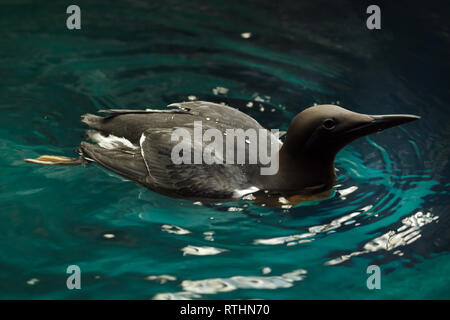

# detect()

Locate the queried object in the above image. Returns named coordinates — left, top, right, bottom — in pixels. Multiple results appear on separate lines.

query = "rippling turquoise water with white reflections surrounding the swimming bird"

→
left=0, top=0, right=450, bottom=299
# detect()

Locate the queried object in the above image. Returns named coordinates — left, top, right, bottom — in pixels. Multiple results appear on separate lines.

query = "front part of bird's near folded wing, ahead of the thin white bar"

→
left=140, top=128, right=254, bottom=199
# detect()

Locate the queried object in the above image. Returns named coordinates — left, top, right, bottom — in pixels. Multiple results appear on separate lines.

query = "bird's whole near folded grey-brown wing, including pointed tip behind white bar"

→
left=80, top=128, right=257, bottom=199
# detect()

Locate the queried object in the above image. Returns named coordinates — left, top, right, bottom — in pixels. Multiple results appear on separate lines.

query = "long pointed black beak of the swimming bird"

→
left=347, top=114, right=420, bottom=137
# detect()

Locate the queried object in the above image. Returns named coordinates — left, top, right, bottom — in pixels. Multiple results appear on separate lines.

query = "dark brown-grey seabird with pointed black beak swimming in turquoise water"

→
left=25, top=101, right=420, bottom=204
